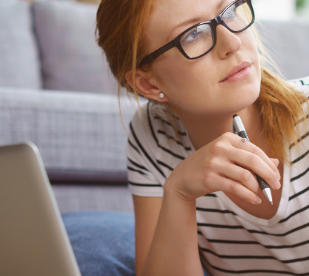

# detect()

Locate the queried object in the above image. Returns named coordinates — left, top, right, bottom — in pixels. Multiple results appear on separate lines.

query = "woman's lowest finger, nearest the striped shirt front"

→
left=215, top=175, right=262, bottom=205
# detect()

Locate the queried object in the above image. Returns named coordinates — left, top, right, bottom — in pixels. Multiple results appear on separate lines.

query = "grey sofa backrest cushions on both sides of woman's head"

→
left=0, top=0, right=309, bottom=94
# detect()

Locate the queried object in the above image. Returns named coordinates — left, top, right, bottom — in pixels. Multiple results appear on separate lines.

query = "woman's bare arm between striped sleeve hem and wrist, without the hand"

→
left=134, top=191, right=203, bottom=276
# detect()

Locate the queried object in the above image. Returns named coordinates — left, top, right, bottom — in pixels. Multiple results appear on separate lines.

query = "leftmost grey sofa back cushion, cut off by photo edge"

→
left=0, top=0, right=41, bottom=89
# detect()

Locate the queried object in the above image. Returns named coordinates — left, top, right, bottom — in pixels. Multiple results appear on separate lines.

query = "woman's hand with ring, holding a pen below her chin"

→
left=165, top=132, right=280, bottom=204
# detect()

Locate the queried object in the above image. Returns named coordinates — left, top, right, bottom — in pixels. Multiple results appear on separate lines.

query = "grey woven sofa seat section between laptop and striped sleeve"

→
left=0, top=87, right=135, bottom=184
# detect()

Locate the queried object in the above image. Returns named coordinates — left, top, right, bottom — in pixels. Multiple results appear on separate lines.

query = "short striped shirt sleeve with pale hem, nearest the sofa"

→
left=126, top=106, right=164, bottom=197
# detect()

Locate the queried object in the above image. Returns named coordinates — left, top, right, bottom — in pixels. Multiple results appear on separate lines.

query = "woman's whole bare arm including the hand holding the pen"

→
left=134, top=134, right=277, bottom=276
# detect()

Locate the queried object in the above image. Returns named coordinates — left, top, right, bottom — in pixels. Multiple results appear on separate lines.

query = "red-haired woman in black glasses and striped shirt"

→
left=97, top=0, right=309, bottom=276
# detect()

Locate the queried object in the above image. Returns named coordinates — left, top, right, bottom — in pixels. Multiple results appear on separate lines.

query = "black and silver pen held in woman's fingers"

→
left=233, top=114, right=273, bottom=204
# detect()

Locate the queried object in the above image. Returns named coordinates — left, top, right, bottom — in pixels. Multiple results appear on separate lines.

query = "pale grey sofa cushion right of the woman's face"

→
left=257, top=19, right=309, bottom=79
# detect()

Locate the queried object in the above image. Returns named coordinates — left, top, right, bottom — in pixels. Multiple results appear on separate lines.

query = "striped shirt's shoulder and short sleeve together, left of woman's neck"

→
left=126, top=102, right=188, bottom=196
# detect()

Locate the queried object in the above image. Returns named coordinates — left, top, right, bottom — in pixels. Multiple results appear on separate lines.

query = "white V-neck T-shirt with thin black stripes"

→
left=126, top=77, right=309, bottom=276
